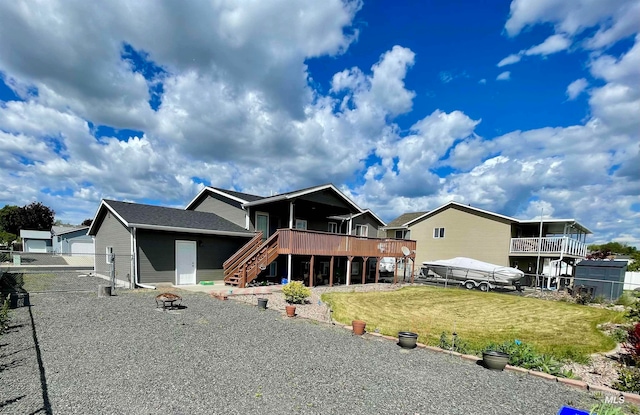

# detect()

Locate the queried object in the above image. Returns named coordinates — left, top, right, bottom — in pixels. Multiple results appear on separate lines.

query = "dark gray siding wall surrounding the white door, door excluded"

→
left=137, top=229, right=249, bottom=284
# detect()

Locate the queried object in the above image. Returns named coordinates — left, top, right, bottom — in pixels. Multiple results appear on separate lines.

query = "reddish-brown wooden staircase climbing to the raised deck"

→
left=222, top=231, right=279, bottom=288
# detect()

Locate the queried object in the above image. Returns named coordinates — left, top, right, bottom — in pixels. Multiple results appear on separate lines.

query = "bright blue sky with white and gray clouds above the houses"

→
left=0, top=0, right=640, bottom=246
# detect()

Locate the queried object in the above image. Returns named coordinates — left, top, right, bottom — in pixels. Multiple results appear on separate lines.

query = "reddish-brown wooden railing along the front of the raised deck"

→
left=278, top=229, right=416, bottom=257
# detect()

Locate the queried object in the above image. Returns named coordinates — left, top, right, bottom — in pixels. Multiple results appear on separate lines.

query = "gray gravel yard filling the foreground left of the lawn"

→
left=0, top=282, right=596, bottom=415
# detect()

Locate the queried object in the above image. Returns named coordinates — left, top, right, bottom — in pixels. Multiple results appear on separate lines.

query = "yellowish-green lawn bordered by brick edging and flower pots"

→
left=322, top=287, right=624, bottom=358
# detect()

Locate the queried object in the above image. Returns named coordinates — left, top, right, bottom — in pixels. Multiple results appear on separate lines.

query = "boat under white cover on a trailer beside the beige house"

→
left=422, top=257, right=524, bottom=291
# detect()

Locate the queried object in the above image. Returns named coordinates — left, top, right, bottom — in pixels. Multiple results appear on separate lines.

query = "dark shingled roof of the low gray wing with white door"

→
left=104, top=200, right=251, bottom=235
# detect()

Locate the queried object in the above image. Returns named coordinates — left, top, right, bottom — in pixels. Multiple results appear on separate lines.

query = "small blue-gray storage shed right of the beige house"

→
left=573, top=260, right=627, bottom=301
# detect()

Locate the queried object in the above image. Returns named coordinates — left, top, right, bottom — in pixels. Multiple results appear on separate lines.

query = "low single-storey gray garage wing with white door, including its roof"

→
left=88, top=200, right=253, bottom=287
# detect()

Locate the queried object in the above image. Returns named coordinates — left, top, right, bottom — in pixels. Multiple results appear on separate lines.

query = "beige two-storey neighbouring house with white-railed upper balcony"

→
left=384, top=202, right=592, bottom=282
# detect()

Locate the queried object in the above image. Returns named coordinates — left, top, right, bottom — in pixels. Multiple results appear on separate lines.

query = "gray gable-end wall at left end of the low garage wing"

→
left=95, top=211, right=131, bottom=281
